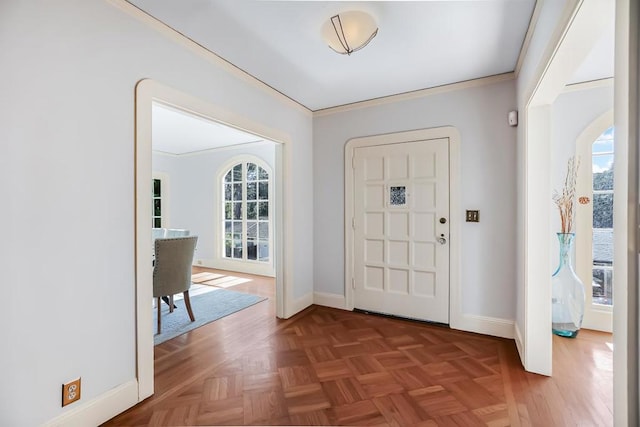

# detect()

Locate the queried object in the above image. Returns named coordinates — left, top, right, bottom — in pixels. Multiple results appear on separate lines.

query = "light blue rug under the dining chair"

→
left=153, top=285, right=266, bottom=345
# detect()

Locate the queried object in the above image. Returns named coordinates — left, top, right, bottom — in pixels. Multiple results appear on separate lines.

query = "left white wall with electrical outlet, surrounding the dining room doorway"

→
left=0, top=0, right=313, bottom=426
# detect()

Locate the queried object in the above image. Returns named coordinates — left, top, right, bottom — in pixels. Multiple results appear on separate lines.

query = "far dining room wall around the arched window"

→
left=152, top=142, right=275, bottom=270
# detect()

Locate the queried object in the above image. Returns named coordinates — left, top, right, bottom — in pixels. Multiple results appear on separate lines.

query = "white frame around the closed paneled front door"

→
left=344, top=126, right=462, bottom=329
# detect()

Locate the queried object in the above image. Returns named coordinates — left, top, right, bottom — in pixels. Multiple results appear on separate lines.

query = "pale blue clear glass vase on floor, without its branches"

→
left=551, top=233, right=585, bottom=338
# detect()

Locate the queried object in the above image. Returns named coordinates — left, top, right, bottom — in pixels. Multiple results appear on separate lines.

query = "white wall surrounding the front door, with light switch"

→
left=313, top=80, right=516, bottom=320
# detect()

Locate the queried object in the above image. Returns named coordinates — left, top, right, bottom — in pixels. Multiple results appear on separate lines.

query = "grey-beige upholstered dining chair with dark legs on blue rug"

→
left=153, top=236, right=198, bottom=333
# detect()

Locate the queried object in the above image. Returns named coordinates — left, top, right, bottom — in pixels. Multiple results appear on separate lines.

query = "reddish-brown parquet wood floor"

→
left=105, top=269, right=613, bottom=427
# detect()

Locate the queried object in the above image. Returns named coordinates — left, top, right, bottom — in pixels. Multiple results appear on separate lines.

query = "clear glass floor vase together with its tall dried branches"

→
left=551, top=157, right=585, bottom=338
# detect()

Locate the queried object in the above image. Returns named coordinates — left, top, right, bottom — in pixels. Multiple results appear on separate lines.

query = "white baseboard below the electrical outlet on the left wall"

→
left=44, top=380, right=138, bottom=427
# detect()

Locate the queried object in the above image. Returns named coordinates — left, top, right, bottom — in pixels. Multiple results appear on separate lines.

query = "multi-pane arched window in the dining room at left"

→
left=222, top=161, right=271, bottom=262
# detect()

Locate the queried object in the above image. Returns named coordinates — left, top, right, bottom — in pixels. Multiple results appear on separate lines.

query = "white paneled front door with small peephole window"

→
left=353, top=138, right=449, bottom=323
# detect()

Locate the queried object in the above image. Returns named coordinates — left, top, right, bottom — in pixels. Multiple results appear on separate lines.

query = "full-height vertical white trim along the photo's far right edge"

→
left=613, top=0, right=640, bottom=426
